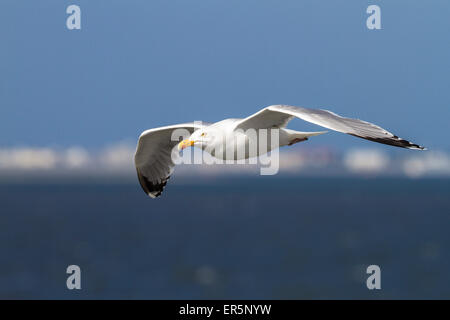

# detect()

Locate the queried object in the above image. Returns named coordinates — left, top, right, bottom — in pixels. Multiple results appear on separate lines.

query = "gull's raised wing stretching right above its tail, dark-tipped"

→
left=236, top=105, right=425, bottom=150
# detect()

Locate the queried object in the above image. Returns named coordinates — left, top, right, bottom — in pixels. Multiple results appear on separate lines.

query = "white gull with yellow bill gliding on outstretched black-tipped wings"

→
left=134, top=105, right=425, bottom=198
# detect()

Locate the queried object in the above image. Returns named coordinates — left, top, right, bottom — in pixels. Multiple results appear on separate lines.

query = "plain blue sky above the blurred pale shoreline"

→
left=0, top=0, right=450, bottom=150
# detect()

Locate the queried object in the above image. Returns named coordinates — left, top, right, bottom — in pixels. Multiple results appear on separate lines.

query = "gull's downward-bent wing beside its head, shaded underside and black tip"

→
left=134, top=123, right=205, bottom=198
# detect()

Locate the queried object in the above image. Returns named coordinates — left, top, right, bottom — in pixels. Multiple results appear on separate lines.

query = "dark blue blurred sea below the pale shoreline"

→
left=0, top=176, right=450, bottom=299
